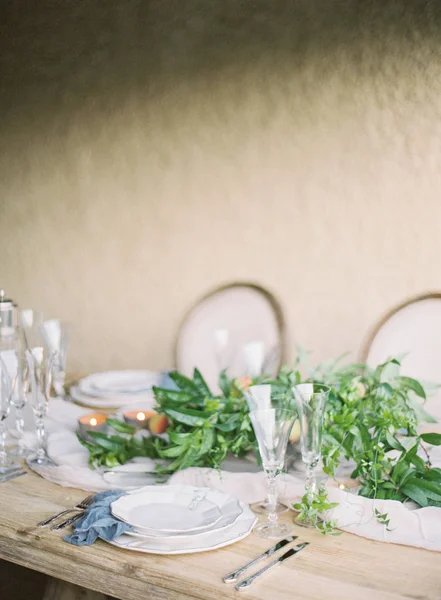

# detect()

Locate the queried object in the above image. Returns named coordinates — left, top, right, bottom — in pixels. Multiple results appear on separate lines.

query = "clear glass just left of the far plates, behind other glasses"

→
left=42, top=319, right=70, bottom=398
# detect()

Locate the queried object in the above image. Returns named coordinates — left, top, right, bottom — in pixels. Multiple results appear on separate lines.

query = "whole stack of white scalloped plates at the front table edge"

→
left=110, top=485, right=256, bottom=554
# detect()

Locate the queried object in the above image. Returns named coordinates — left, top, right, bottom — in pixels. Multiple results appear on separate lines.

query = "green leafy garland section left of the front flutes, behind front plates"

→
left=79, top=369, right=255, bottom=473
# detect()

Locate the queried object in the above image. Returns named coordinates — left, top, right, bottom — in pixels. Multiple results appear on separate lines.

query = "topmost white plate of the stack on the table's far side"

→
left=78, top=370, right=162, bottom=396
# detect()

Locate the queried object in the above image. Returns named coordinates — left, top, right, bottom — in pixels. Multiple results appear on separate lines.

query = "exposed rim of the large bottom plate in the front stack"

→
left=109, top=502, right=257, bottom=554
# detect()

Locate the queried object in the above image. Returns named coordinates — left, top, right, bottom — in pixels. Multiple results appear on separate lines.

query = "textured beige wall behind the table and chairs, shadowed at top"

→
left=0, top=0, right=441, bottom=370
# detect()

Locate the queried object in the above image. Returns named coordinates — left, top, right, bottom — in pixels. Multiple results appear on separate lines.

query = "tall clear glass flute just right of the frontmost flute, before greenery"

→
left=292, top=383, right=330, bottom=527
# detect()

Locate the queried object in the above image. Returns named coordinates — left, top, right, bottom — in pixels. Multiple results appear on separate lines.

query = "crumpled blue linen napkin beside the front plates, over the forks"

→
left=64, top=490, right=133, bottom=546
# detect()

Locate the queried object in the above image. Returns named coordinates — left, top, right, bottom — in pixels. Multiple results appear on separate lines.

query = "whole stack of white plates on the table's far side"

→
left=70, top=371, right=163, bottom=408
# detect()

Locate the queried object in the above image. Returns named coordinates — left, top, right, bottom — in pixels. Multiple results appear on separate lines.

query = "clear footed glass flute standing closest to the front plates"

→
left=250, top=404, right=296, bottom=539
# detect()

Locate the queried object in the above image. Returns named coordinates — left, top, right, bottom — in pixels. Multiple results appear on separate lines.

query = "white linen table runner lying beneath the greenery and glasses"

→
left=18, top=399, right=441, bottom=552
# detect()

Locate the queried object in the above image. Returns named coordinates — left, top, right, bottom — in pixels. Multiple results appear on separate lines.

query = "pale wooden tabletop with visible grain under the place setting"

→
left=0, top=473, right=441, bottom=600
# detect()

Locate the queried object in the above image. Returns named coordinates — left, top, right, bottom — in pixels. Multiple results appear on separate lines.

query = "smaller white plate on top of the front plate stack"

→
left=111, top=485, right=222, bottom=534
